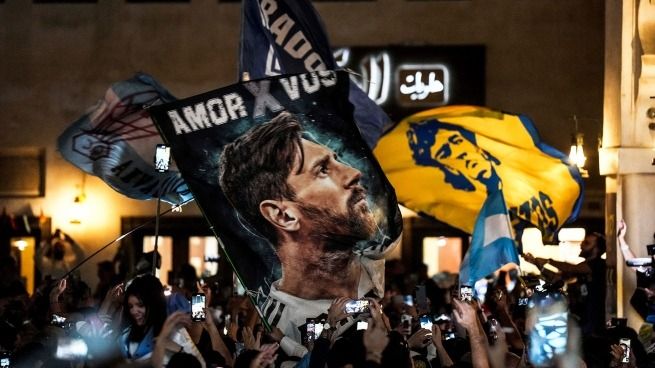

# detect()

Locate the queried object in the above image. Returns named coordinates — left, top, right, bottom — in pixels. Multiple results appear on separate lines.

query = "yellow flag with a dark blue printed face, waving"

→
left=374, top=106, right=583, bottom=239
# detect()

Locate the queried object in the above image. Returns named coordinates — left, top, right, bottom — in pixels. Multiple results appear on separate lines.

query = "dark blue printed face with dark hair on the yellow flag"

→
left=407, top=120, right=500, bottom=191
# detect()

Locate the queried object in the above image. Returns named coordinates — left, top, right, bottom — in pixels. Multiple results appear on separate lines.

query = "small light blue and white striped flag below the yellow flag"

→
left=459, top=189, right=519, bottom=286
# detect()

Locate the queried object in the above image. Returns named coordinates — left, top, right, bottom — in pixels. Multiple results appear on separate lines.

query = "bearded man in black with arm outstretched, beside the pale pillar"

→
left=523, top=232, right=607, bottom=334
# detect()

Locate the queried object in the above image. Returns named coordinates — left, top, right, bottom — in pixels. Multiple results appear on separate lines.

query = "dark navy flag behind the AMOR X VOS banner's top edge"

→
left=239, top=0, right=393, bottom=148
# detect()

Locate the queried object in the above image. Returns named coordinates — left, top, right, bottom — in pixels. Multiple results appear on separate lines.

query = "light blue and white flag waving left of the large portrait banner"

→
left=57, top=73, right=193, bottom=204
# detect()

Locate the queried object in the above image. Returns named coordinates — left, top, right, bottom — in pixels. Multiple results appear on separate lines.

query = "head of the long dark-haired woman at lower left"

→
left=123, top=274, right=166, bottom=335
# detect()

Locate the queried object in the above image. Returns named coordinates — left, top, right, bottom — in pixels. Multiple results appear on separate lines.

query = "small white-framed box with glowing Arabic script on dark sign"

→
left=396, top=64, right=449, bottom=107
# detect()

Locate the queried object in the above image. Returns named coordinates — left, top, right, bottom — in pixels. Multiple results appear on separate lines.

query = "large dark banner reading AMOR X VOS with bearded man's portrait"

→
left=150, top=71, right=402, bottom=342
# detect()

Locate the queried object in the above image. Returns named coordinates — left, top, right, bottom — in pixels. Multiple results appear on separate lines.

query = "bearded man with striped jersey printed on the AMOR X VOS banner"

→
left=219, top=112, right=392, bottom=356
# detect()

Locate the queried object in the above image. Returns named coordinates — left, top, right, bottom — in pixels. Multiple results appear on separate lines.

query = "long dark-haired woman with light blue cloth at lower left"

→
left=118, top=274, right=166, bottom=361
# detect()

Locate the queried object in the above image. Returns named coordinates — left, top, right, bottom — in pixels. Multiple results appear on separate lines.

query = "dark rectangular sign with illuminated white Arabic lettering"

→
left=334, top=45, right=485, bottom=120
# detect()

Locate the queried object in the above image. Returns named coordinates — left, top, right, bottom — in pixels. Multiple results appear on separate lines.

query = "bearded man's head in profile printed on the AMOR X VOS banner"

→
left=219, top=112, right=375, bottom=246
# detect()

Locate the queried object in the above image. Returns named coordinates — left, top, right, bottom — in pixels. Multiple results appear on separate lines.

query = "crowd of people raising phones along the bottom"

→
left=0, top=229, right=655, bottom=368
